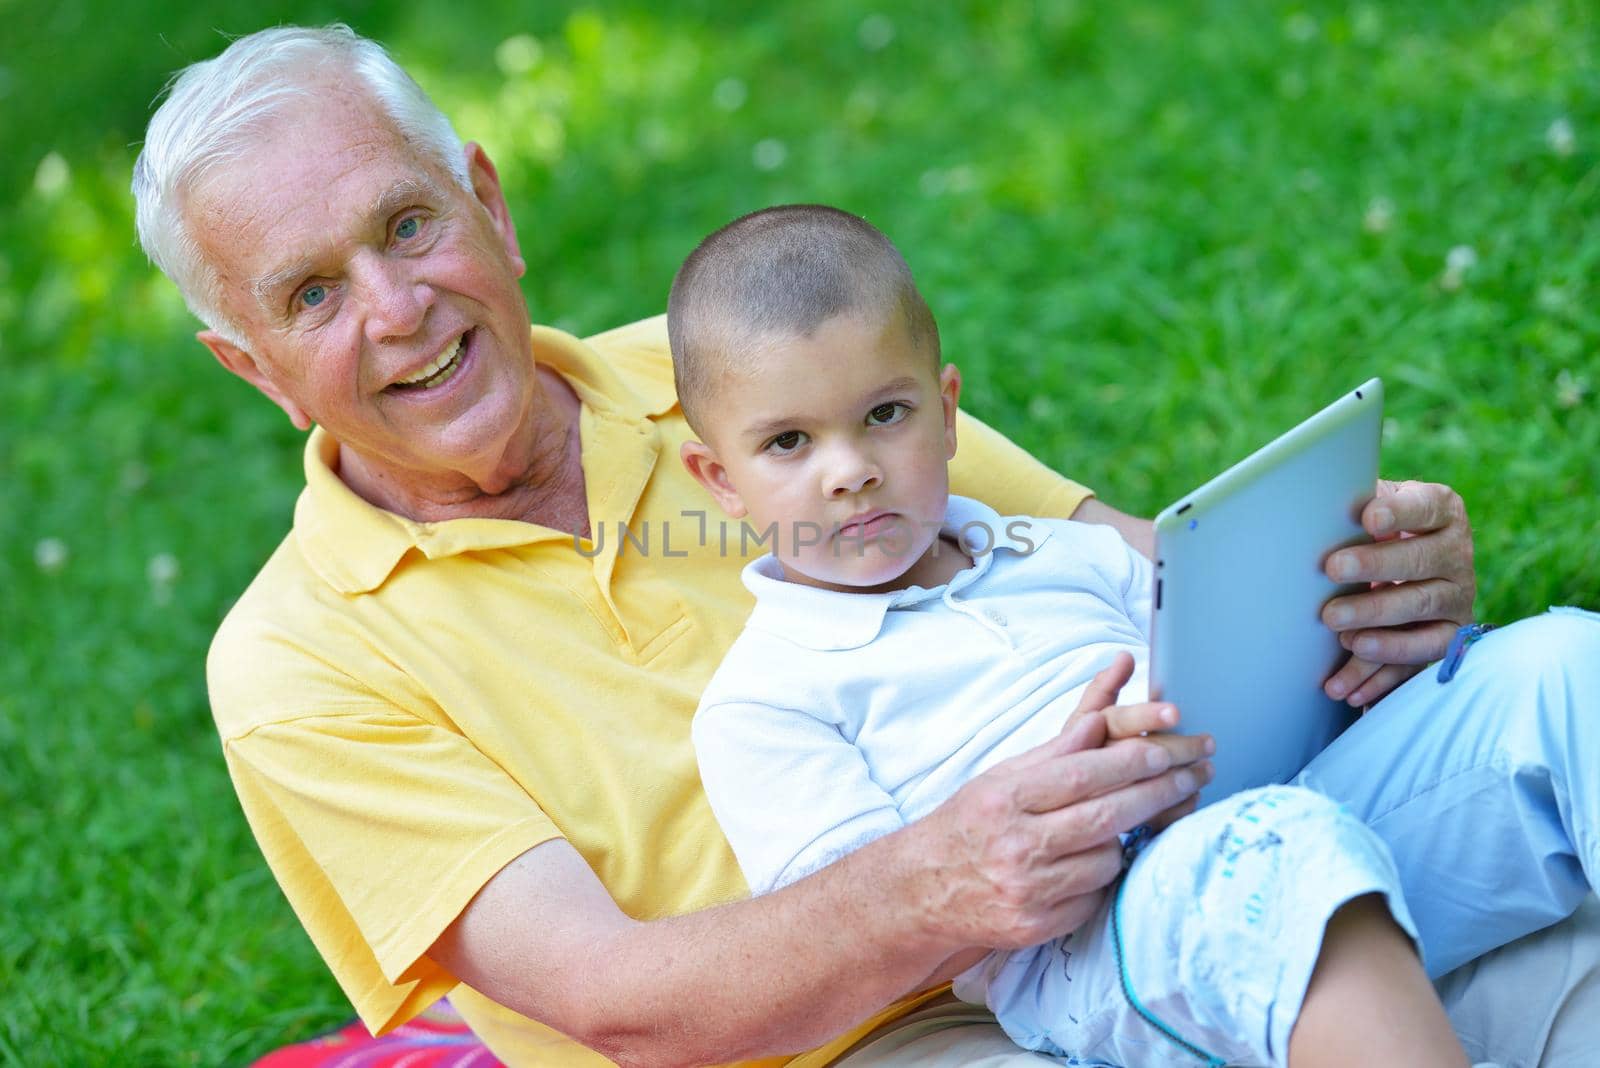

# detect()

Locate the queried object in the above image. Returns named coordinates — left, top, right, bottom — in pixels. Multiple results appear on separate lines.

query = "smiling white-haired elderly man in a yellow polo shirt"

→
left=134, top=27, right=1592, bottom=1065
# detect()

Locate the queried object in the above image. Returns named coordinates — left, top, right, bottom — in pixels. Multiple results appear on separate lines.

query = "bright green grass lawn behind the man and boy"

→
left=0, top=0, right=1600, bottom=1065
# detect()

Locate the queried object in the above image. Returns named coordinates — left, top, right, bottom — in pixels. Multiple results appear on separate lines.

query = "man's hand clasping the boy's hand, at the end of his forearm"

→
left=915, top=700, right=1211, bottom=948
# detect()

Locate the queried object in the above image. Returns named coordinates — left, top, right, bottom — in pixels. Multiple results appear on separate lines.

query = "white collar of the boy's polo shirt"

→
left=742, top=494, right=1050, bottom=652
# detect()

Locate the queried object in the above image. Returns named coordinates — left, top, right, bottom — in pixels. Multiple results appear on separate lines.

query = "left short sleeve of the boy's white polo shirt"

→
left=693, top=702, right=906, bottom=894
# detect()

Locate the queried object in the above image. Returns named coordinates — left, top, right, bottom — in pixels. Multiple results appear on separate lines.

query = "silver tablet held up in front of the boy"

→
left=1150, top=379, right=1384, bottom=804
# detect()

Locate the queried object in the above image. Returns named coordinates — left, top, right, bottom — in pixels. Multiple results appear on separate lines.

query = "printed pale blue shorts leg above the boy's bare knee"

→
left=955, top=787, right=1416, bottom=1068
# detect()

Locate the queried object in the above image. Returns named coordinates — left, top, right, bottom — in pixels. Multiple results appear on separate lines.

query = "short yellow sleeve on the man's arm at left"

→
left=224, top=700, right=560, bottom=1033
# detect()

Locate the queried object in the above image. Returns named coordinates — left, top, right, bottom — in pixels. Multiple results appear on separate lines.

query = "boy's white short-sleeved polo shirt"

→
left=693, top=496, right=1154, bottom=894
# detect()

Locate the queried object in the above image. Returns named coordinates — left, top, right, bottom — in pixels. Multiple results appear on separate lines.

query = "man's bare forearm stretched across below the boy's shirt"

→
left=510, top=836, right=954, bottom=1066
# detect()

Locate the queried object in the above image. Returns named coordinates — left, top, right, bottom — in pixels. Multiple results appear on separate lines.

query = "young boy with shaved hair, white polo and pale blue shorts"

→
left=669, top=206, right=1466, bottom=1068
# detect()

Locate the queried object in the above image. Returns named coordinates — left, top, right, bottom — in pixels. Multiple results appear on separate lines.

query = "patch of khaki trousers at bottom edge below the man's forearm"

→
left=834, top=994, right=1056, bottom=1068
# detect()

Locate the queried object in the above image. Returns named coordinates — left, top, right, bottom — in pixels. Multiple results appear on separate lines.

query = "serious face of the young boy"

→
left=682, top=313, right=962, bottom=592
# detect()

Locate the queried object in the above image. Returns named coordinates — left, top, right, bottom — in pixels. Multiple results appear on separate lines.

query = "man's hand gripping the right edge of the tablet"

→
left=1322, top=481, right=1477, bottom=707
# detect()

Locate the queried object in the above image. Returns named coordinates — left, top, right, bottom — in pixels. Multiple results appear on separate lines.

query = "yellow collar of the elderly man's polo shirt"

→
left=294, top=320, right=677, bottom=593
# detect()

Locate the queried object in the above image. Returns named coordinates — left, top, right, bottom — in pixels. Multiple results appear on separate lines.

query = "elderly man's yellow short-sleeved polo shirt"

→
left=206, top=318, right=1088, bottom=1065
